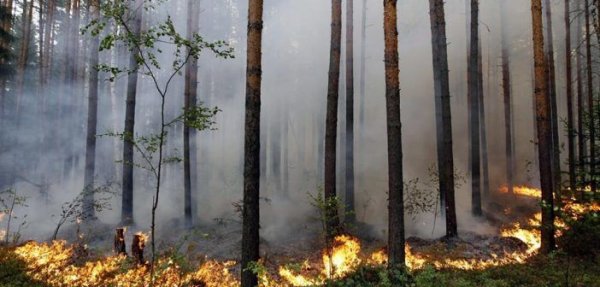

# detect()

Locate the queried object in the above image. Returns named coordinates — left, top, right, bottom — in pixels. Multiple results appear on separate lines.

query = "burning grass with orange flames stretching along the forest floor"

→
left=0, top=187, right=600, bottom=287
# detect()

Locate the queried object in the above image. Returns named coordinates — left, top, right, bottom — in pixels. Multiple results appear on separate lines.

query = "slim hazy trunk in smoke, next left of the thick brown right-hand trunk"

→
left=500, top=1, right=515, bottom=194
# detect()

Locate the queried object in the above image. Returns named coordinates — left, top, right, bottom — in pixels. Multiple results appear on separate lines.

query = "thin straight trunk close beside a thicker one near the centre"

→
left=344, top=0, right=356, bottom=223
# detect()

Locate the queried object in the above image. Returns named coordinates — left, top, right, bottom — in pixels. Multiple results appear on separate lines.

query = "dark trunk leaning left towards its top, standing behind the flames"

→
left=429, top=0, right=458, bottom=238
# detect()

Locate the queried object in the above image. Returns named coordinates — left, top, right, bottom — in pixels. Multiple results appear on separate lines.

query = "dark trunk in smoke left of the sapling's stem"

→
left=83, top=0, right=100, bottom=219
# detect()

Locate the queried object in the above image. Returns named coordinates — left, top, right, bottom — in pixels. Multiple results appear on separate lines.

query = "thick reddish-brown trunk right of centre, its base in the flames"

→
left=383, top=0, right=406, bottom=269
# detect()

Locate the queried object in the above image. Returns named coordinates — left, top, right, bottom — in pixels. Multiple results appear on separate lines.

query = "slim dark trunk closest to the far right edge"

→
left=585, top=0, right=596, bottom=196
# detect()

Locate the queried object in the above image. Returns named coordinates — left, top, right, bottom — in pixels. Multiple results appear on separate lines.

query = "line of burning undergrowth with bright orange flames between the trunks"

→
left=1, top=186, right=600, bottom=287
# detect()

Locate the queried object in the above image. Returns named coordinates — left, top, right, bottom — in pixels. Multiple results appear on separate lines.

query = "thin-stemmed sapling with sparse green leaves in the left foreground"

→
left=83, top=0, right=233, bottom=282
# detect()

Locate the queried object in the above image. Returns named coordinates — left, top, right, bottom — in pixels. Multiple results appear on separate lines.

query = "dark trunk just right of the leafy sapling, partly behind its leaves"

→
left=183, top=0, right=200, bottom=227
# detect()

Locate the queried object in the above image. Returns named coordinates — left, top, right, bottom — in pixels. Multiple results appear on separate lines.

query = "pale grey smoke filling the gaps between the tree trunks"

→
left=0, top=0, right=565, bottom=246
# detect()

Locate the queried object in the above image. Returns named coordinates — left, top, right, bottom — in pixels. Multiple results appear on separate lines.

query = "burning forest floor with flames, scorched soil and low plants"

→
left=0, top=189, right=600, bottom=287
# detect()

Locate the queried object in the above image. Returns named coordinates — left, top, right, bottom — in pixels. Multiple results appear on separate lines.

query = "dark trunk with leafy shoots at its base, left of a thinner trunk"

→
left=324, top=0, right=342, bottom=241
